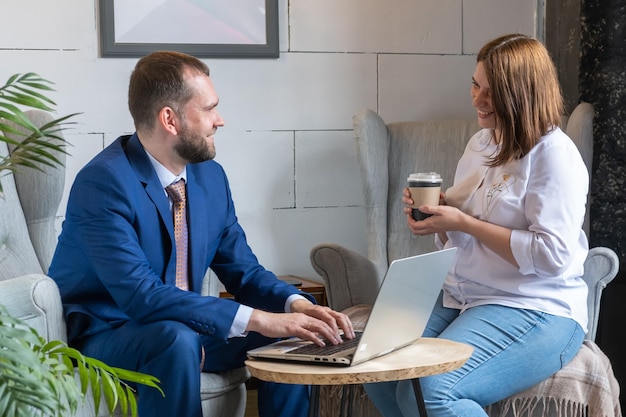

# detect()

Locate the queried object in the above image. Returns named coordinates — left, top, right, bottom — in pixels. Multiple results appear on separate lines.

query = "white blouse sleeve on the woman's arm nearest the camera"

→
left=510, top=130, right=589, bottom=277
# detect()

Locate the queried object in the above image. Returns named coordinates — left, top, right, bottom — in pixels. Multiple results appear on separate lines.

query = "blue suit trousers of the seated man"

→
left=75, top=321, right=309, bottom=417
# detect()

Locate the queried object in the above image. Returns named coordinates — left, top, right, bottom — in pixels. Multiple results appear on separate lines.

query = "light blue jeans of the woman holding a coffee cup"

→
left=365, top=296, right=585, bottom=417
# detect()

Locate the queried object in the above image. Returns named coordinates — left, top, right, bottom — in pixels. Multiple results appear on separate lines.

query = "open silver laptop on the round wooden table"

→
left=248, top=248, right=456, bottom=366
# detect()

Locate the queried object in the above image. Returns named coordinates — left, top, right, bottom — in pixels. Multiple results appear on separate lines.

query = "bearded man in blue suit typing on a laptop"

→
left=49, top=51, right=354, bottom=417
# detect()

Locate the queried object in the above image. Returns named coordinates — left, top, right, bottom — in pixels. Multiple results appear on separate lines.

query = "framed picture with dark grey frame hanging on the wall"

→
left=99, top=0, right=279, bottom=58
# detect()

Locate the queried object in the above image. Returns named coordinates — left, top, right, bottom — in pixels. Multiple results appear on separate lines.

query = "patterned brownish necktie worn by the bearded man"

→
left=165, top=179, right=189, bottom=290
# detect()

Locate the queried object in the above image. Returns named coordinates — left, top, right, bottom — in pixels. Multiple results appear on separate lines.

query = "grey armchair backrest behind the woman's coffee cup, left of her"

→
left=353, top=110, right=479, bottom=277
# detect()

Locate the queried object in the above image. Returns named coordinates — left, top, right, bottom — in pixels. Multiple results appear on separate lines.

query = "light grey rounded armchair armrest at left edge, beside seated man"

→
left=0, top=274, right=67, bottom=342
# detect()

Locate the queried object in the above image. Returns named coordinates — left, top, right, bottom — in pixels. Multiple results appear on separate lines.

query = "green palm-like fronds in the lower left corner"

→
left=0, top=305, right=163, bottom=417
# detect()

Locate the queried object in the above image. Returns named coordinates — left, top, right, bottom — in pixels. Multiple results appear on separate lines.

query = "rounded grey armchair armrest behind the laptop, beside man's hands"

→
left=310, top=243, right=382, bottom=311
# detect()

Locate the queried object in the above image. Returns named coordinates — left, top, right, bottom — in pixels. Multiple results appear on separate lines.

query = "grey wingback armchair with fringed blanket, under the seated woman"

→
left=310, top=103, right=621, bottom=416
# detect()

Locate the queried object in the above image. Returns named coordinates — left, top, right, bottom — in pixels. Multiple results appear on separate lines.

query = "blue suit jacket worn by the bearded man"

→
left=48, top=134, right=310, bottom=341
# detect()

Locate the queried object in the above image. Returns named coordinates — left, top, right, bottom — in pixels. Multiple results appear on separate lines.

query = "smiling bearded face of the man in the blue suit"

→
left=174, top=73, right=224, bottom=163
